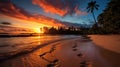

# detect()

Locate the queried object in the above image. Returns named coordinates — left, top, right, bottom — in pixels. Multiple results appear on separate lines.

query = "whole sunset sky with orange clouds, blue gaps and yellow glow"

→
left=0, top=0, right=108, bottom=33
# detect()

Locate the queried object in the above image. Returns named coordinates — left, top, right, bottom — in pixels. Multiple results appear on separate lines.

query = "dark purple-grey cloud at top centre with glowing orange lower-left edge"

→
left=32, top=0, right=86, bottom=16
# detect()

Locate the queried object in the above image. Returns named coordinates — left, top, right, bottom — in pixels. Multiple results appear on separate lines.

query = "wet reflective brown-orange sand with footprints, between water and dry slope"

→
left=0, top=37, right=120, bottom=67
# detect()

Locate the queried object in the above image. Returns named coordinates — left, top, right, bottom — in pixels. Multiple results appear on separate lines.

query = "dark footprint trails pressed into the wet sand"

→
left=39, top=43, right=89, bottom=67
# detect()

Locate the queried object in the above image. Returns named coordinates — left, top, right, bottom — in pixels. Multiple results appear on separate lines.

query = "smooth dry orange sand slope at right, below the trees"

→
left=90, top=35, right=120, bottom=53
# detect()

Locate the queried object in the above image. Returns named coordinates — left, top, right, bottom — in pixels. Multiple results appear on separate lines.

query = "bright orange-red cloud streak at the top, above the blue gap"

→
left=33, top=0, right=68, bottom=16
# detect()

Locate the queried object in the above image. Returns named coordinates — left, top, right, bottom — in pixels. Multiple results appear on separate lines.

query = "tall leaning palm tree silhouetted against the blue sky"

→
left=87, top=1, right=99, bottom=24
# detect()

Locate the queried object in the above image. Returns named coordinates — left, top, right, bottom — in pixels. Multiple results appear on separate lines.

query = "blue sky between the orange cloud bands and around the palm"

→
left=12, top=0, right=108, bottom=24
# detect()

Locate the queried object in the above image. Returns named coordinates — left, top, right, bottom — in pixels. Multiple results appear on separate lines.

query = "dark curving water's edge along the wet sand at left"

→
left=0, top=37, right=76, bottom=62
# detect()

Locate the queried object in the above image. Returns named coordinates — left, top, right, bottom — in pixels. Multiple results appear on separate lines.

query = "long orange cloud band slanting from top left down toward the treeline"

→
left=0, top=2, right=64, bottom=26
